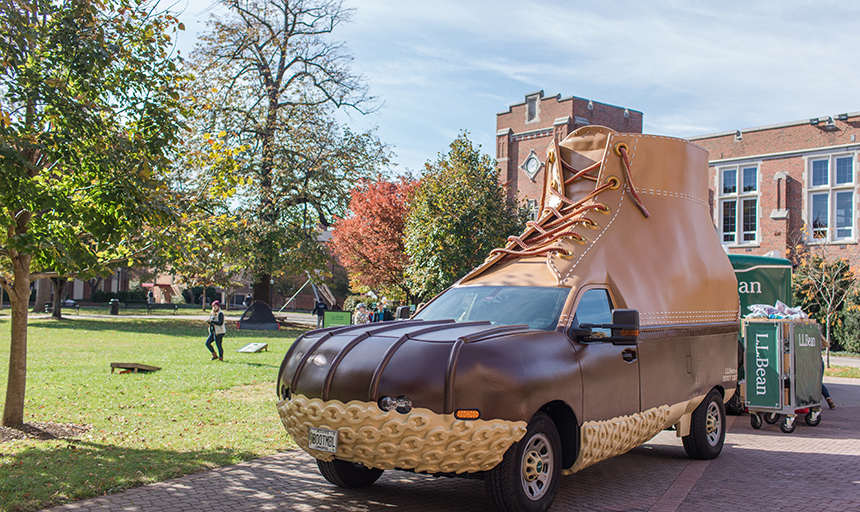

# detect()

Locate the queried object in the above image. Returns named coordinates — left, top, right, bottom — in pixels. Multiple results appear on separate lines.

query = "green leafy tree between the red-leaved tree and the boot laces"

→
left=405, top=132, right=528, bottom=298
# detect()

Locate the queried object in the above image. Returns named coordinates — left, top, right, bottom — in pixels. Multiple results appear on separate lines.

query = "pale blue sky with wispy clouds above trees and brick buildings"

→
left=177, top=0, right=860, bottom=171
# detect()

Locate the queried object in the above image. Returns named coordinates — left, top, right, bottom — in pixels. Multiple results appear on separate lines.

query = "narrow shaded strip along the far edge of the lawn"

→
left=4, top=317, right=310, bottom=339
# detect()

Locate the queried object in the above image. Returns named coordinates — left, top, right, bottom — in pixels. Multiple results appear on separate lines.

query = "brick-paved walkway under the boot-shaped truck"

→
left=43, top=378, right=860, bottom=512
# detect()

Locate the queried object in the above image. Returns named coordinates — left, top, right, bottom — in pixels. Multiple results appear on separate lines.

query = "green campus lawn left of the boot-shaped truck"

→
left=0, top=314, right=303, bottom=512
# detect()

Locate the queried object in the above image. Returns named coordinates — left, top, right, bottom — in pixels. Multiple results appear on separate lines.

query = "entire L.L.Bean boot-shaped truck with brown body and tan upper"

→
left=277, top=126, right=739, bottom=511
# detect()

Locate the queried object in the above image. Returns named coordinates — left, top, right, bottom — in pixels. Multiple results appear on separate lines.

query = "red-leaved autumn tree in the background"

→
left=331, top=177, right=418, bottom=303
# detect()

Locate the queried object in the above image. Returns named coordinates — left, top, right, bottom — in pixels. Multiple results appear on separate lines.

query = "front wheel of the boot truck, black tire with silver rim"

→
left=484, top=412, right=561, bottom=512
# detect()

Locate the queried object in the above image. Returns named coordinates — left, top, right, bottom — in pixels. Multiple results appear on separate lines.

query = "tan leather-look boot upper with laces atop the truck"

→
left=461, top=126, right=738, bottom=327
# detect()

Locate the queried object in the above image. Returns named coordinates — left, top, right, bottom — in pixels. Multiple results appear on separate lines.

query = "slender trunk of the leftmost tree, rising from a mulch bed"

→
left=3, top=262, right=30, bottom=428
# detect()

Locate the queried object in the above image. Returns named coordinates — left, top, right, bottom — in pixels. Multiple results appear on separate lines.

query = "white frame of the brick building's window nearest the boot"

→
left=715, top=162, right=761, bottom=247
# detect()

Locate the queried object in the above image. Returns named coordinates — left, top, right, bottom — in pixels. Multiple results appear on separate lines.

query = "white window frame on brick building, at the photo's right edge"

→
left=804, top=151, right=858, bottom=245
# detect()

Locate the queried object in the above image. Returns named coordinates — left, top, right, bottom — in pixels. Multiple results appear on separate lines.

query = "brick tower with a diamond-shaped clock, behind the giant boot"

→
left=496, top=91, right=642, bottom=215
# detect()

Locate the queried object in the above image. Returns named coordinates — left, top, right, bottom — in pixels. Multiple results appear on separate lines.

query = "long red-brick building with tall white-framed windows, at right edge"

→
left=689, top=112, right=860, bottom=257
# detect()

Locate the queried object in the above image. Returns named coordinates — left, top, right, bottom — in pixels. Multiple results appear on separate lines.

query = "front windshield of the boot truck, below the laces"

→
left=414, top=286, right=570, bottom=331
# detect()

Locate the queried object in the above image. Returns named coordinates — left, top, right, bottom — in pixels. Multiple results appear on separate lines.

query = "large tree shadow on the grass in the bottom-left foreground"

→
left=0, top=440, right=259, bottom=511
